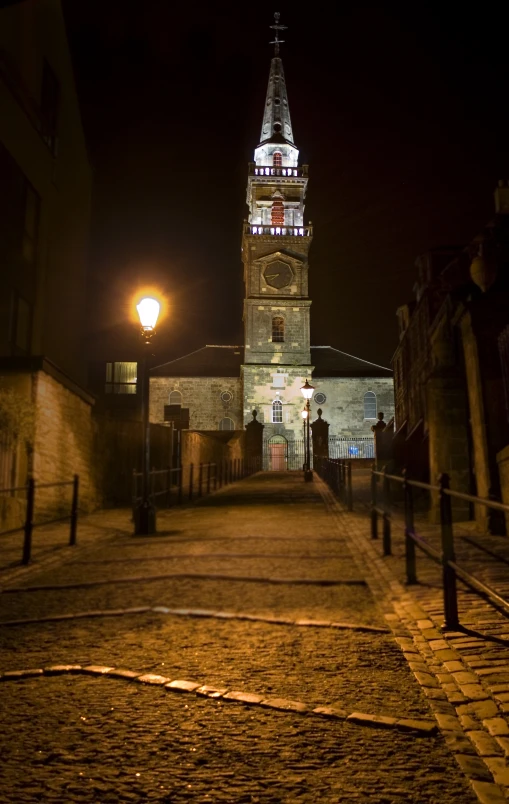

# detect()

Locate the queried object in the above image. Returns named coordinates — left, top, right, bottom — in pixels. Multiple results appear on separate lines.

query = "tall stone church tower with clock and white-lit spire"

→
left=242, top=14, right=313, bottom=441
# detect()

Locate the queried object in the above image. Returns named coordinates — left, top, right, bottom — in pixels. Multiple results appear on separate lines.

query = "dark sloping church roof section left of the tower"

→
left=150, top=346, right=244, bottom=377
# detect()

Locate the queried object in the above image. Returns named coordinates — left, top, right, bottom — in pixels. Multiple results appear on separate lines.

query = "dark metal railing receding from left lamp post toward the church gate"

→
left=132, top=458, right=261, bottom=508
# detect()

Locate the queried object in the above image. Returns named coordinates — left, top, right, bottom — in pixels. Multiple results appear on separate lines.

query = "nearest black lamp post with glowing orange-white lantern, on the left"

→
left=134, top=297, right=160, bottom=536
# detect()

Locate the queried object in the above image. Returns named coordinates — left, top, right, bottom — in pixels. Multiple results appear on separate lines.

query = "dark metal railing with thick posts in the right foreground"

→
left=371, top=467, right=509, bottom=629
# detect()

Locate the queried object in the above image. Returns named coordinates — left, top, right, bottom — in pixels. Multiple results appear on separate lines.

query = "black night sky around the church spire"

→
left=64, top=0, right=509, bottom=365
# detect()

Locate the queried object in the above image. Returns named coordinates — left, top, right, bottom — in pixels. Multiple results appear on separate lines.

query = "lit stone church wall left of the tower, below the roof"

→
left=150, top=377, right=243, bottom=430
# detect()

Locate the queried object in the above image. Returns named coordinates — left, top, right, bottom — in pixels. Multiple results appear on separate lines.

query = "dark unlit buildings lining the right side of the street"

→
left=393, top=182, right=509, bottom=527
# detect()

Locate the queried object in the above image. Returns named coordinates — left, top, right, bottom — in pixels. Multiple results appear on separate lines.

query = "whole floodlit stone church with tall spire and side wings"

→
left=150, top=25, right=394, bottom=468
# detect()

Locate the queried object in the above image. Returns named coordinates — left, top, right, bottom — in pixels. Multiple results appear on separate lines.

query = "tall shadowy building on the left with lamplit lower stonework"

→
left=0, top=0, right=94, bottom=520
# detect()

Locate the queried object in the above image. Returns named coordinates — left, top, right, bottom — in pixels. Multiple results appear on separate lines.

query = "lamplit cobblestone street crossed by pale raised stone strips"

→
left=0, top=473, right=488, bottom=804
